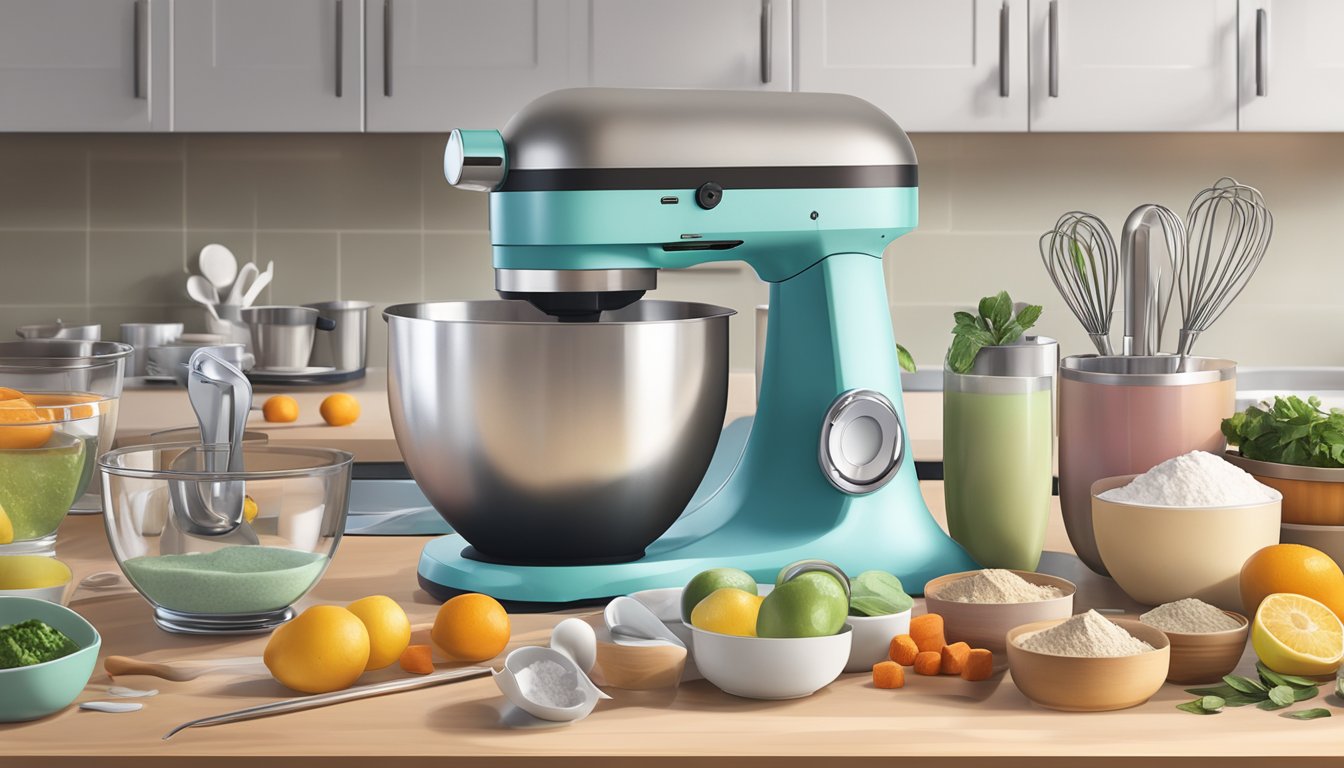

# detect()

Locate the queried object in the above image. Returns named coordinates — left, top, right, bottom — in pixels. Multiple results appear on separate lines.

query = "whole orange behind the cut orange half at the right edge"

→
left=1241, top=543, right=1344, bottom=619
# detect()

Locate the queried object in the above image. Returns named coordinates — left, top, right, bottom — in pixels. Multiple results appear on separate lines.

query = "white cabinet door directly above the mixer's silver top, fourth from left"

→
left=578, top=0, right=793, bottom=90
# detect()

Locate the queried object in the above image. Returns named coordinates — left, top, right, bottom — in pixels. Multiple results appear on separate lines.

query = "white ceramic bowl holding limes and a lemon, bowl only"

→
left=689, top=624, right=853, bottom=699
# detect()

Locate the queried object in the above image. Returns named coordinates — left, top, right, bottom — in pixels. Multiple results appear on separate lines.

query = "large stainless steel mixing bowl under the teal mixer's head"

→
left=383, top=301, right=734, bottom=564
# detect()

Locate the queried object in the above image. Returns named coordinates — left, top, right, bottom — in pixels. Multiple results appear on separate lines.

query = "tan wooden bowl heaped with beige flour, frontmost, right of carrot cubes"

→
left=1008, top=611, right=1171, bottom=712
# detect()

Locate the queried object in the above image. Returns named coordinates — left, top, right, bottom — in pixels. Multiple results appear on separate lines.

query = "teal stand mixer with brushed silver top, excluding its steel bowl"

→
left=387, top=89, right=976, bottom=604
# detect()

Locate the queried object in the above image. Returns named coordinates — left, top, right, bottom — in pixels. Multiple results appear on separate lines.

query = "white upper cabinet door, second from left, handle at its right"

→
left=173, top=0, right=364, bottom=132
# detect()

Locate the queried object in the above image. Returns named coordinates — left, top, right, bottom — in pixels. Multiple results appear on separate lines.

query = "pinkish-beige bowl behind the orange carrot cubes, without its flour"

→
left=925, top=570, right=1078, bottom=654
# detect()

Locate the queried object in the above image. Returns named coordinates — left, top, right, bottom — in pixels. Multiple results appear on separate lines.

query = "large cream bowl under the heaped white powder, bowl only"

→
left=1091, top=475, right=1279, bottom=609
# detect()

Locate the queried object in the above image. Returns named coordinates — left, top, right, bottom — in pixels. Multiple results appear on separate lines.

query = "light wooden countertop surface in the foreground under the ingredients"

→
left=0, top=483, right=1344, bottom=768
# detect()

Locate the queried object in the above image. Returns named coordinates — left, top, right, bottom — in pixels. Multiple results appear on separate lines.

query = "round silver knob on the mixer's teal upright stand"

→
left=818, top=389, right=906, bottom=495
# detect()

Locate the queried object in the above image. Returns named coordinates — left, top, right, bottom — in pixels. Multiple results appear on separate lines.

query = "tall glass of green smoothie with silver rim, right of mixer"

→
left=942, top=336, right=1059, bottom=570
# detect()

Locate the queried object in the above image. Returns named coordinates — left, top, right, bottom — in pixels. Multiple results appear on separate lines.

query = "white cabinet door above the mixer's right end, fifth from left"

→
left=794, top=0, right=1027, bottom=130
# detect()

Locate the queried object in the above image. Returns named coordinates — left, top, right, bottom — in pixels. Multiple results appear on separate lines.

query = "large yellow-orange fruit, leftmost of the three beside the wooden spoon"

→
left=262, top=605, right=368, bottom=693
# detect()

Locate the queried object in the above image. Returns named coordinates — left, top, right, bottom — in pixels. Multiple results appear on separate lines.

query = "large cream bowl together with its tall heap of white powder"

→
left=1091, top=451, right=1282, bottom=609
